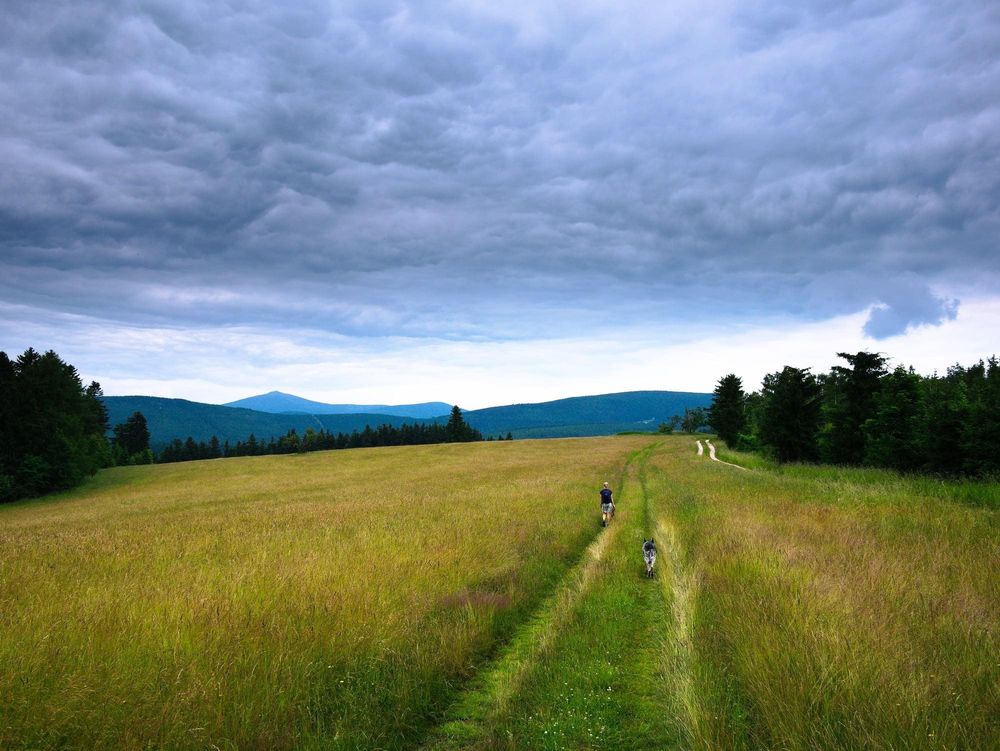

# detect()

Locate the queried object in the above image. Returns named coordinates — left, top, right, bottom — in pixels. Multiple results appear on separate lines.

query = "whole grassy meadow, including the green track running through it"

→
left=0, top=435, right=1000, bottom=751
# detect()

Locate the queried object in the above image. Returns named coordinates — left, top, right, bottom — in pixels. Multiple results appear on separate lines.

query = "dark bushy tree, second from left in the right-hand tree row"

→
left=760, top=365, right=822, bottom=462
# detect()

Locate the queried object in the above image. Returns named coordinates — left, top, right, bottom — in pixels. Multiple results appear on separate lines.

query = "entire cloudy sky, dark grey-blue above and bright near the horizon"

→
left=0, top=0, right=1000, bottom=408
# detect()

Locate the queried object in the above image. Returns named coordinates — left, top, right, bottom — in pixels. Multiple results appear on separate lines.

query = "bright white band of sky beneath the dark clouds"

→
left=0, top=298, right=1000, bottom=409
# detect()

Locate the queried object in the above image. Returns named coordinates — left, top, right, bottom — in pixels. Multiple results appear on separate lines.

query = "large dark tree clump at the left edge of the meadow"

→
left=0, top=348, right=110, bottom=500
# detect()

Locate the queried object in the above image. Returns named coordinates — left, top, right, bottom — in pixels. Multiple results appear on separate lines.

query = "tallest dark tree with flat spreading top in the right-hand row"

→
left=820, top=352, right=886, bottom=464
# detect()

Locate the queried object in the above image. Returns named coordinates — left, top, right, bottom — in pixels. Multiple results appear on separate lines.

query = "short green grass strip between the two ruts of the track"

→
left=470, top=444, right=676, bottom=751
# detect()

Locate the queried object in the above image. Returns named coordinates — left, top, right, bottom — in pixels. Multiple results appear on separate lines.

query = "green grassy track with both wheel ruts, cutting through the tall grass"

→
left=426, top=444, right=685, bottom=751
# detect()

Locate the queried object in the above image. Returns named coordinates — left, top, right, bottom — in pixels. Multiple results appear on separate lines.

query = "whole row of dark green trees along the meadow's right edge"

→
left=708, top=352, right=1000, bottom=476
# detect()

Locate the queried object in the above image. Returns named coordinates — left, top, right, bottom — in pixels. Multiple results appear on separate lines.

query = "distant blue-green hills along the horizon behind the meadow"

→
left=104, top=391, right=712, bottom=450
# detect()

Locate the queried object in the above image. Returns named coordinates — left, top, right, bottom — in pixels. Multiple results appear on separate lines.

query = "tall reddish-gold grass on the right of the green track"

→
left=657, top=438, right=1000, bottom=749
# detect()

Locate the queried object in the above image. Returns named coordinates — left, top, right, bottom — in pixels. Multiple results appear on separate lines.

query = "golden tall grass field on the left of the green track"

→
left=0, top=438, right=641, bottom=749
